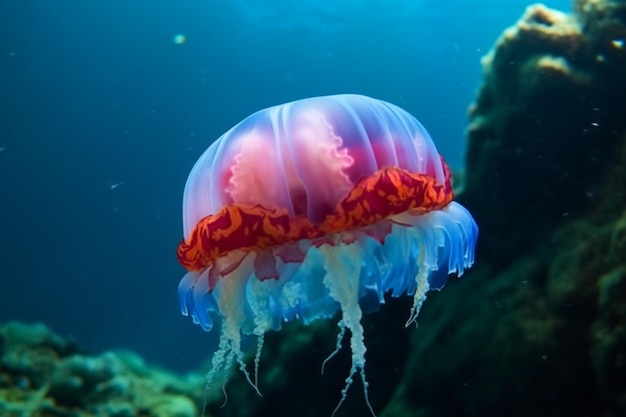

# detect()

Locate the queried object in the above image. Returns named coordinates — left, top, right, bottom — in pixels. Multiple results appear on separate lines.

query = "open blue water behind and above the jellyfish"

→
left=0, top=0, right=571, bottom=369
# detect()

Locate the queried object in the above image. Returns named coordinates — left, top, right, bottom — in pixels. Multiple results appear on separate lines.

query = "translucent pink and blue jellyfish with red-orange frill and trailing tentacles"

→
left=177, top=94, right=478, bottom=415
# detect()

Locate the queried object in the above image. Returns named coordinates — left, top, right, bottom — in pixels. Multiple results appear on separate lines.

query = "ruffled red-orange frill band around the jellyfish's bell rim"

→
left=177, top=159, right=453, bottom=271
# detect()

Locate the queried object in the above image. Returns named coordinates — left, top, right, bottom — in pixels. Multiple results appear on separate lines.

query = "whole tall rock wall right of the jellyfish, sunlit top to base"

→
left=400, top=0, right=626, bottom=416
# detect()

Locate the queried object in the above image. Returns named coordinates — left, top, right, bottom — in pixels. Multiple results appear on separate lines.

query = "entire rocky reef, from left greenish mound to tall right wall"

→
left=0, top=0, right=626, bottom=417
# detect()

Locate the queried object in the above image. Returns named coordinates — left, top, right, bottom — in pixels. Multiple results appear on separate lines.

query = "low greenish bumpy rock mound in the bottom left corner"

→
left=0, top=322, right=204, bottom=417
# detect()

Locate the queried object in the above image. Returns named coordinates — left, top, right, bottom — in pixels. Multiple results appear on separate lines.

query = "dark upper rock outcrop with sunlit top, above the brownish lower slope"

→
left=465, top=1, right=626, bottom=265
